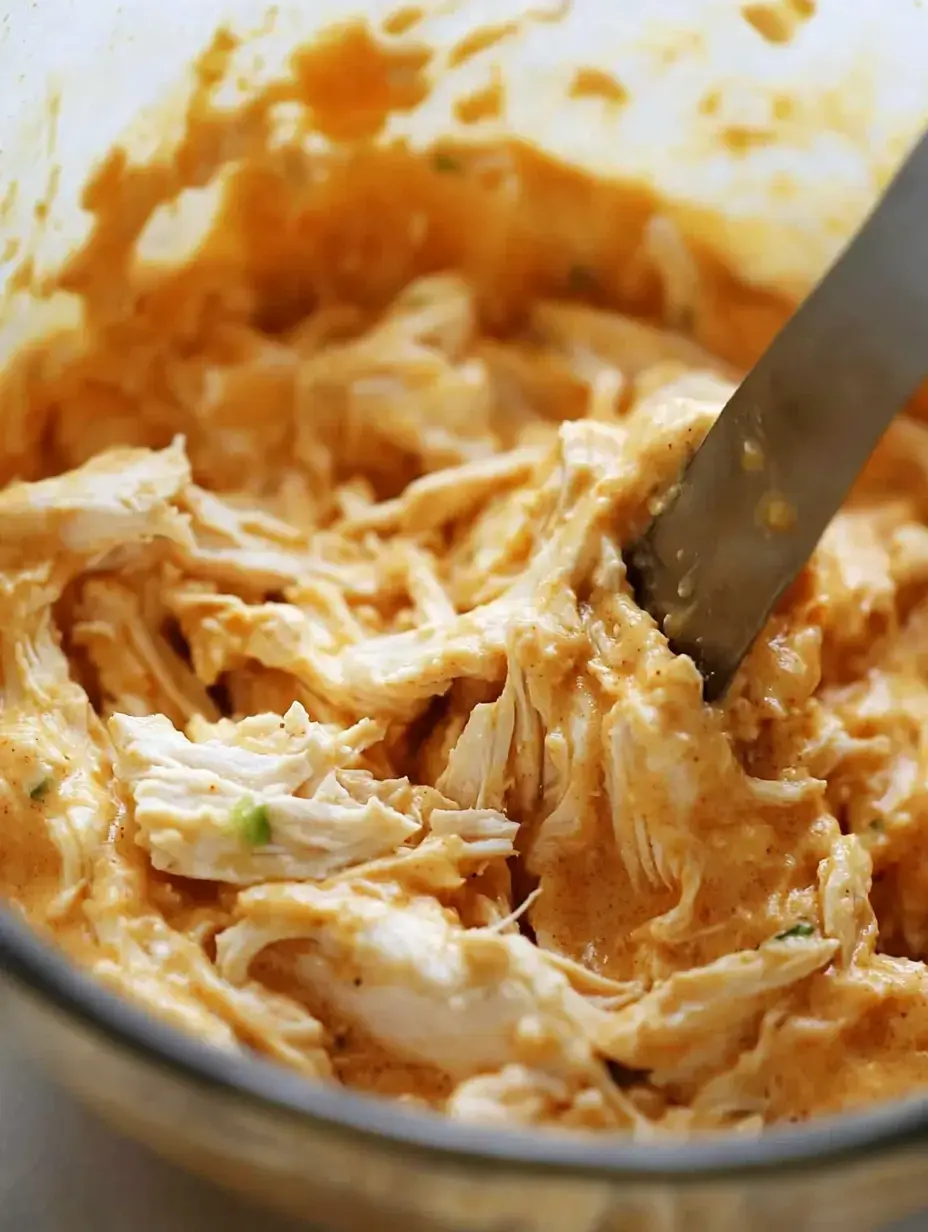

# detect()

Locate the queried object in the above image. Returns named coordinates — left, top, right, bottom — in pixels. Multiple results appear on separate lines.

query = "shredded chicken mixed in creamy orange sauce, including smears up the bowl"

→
left=0, top=14, right=928, bottom=1133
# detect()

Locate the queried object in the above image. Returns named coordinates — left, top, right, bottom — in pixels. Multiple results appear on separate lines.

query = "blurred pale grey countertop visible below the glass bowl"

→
left=0, top=1045, right=928, bottom=1232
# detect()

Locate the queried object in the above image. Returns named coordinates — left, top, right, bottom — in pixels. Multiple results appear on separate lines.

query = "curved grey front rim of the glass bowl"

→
left=0, top=908, right=928, bottom=1184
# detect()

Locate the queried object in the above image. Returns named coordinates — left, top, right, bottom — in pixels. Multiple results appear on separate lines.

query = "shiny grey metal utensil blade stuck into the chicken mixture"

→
left=625, top=136, right=928, bottom=701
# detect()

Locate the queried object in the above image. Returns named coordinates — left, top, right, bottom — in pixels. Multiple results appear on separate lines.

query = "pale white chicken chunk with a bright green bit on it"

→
left=110, top=702, right=419, bottom=886
